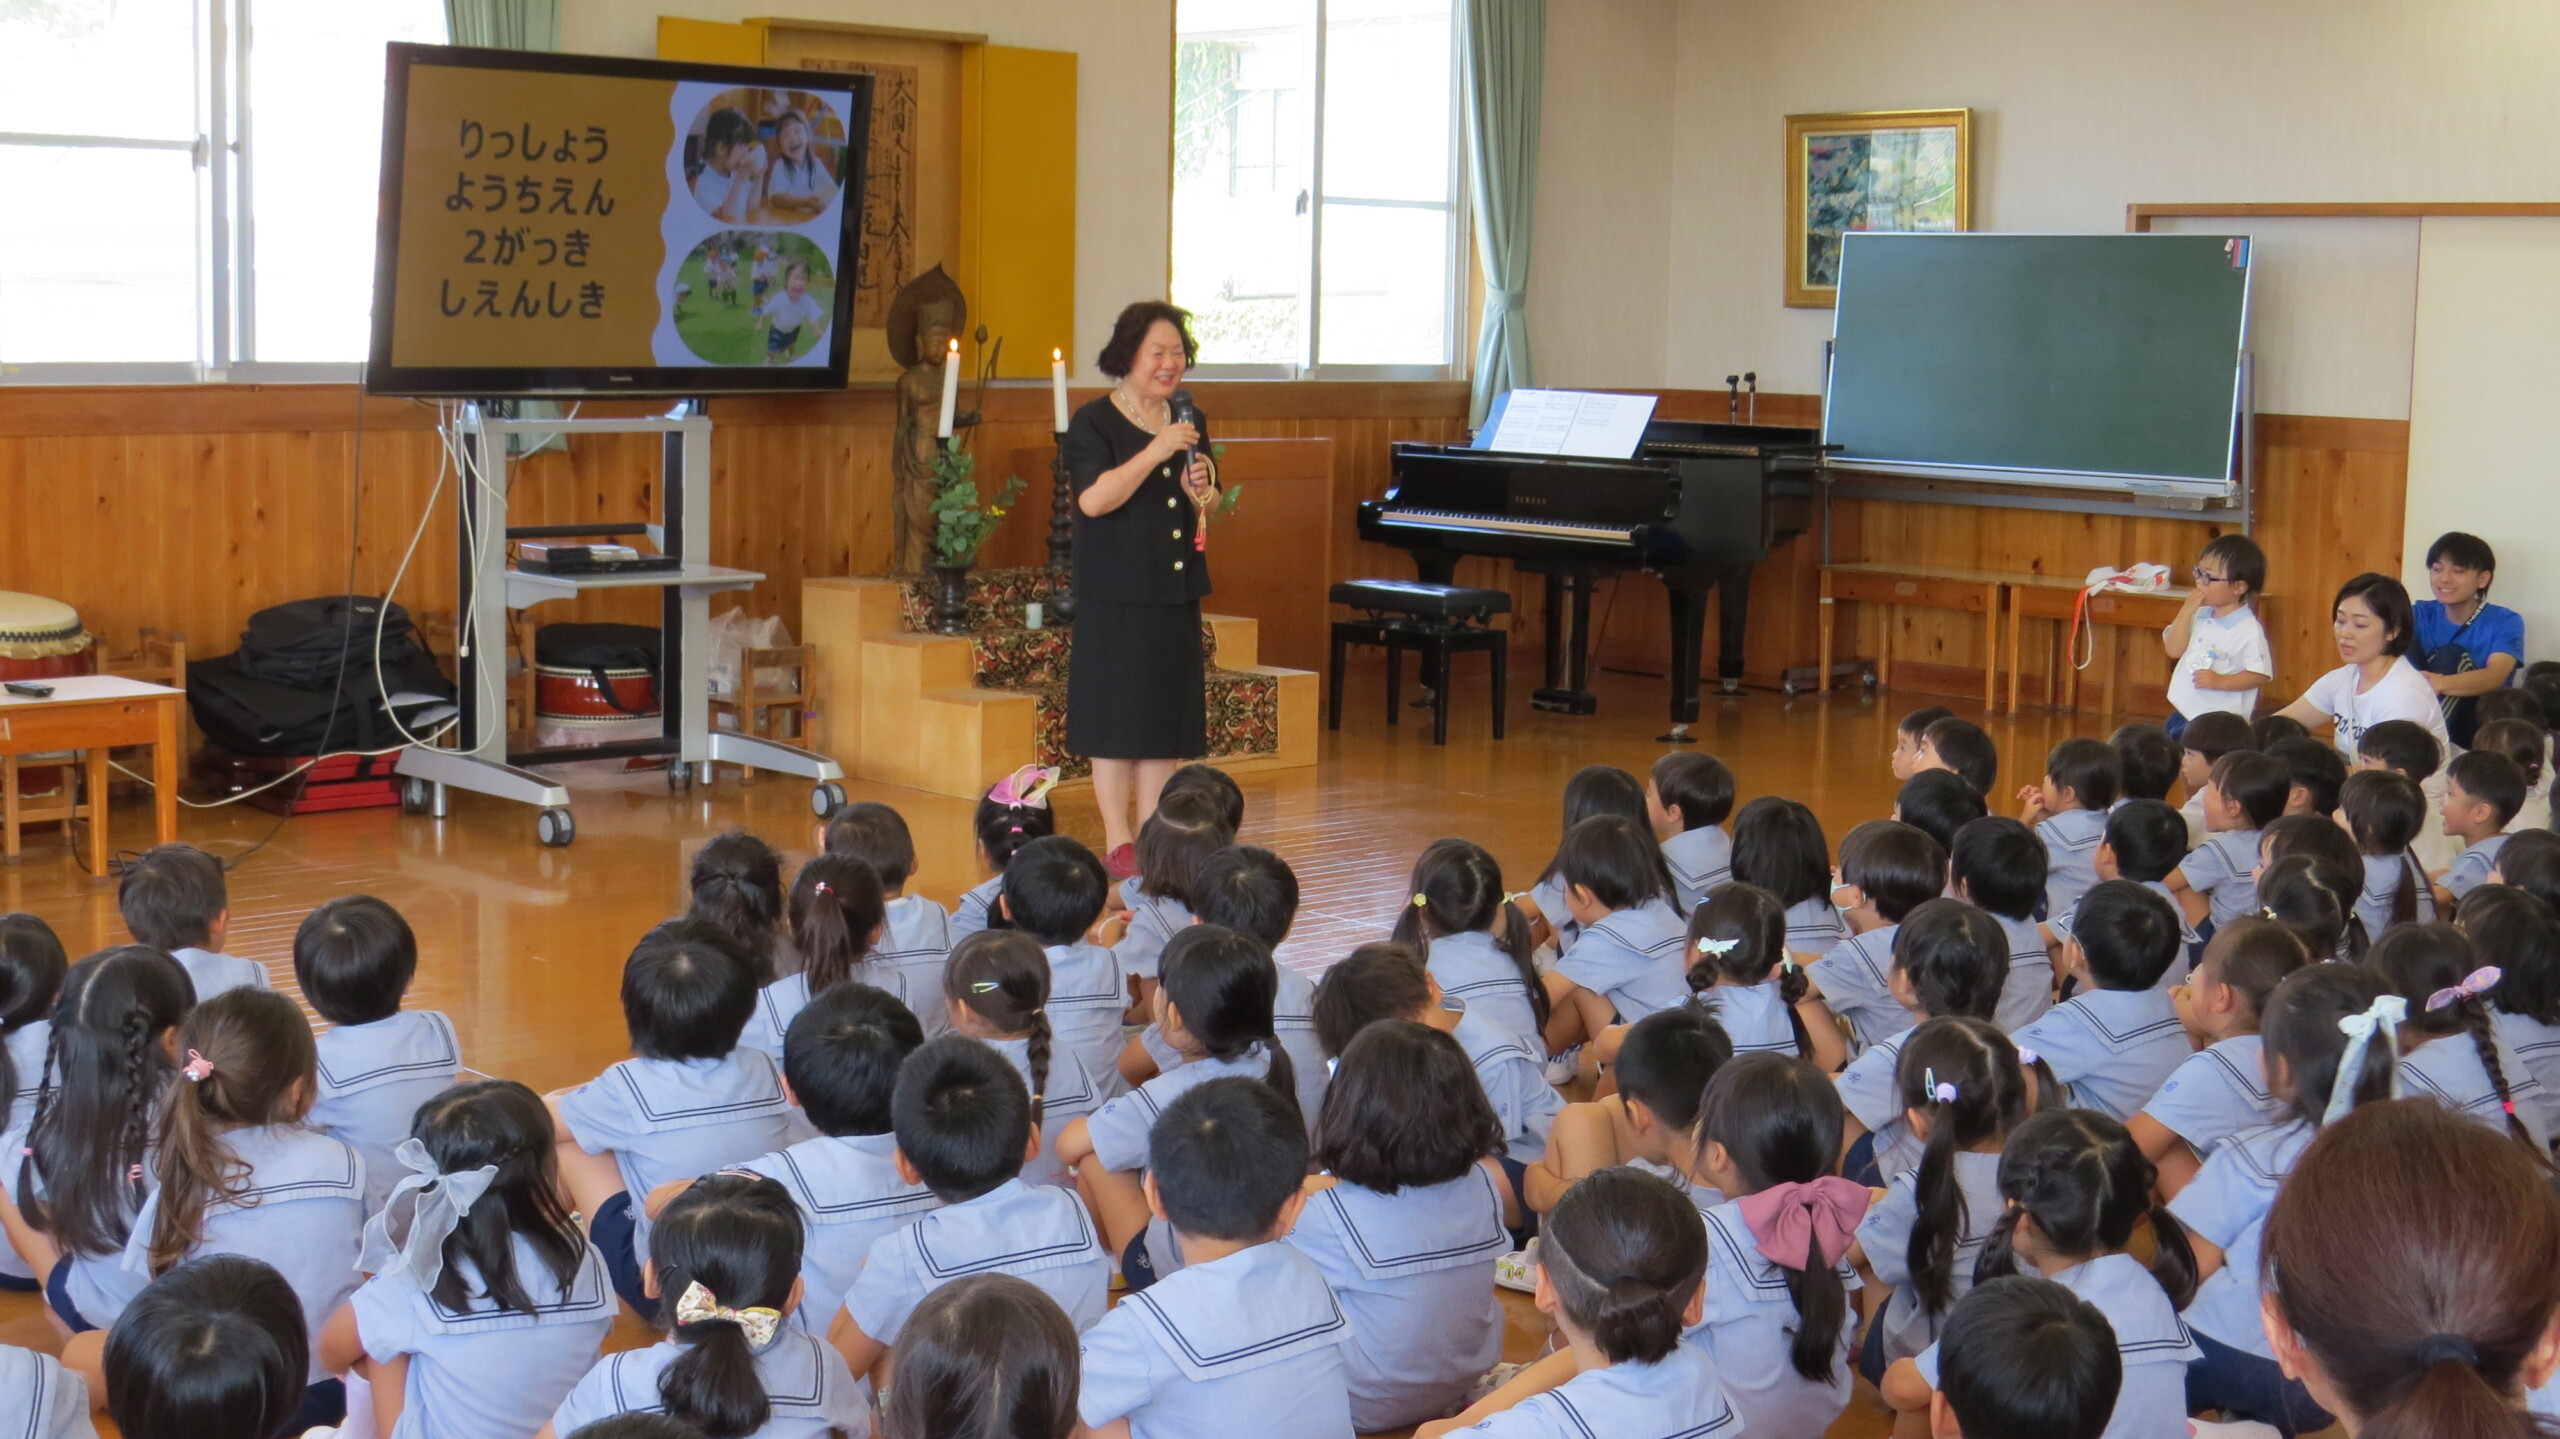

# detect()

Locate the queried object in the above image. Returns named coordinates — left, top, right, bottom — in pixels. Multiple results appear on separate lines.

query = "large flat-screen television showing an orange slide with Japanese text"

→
left=364, top=44, right=870, bottom=397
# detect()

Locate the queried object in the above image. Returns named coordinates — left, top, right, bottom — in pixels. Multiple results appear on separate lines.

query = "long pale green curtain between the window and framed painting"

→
left=1464, top=0, right=1546, bottom=425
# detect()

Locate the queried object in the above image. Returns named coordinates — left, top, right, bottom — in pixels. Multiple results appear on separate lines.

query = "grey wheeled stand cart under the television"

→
left=397, top=402, right=845, bottom=845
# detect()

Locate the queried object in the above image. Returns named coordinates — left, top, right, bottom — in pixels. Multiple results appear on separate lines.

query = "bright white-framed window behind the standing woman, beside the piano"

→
left=1172, top=0, right=1467, bottom=376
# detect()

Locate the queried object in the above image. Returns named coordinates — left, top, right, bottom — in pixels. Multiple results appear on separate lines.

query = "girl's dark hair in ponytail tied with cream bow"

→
left=650, top=1170, right=801, bottom=1439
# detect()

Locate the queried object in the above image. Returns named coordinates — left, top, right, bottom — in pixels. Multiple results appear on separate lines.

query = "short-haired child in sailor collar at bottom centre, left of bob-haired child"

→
left=1075, top=1070, right=1352, bottom=1439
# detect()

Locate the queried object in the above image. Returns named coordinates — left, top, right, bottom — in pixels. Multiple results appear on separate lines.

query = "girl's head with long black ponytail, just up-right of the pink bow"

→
left=1894, top=1017, right=2028, bottom=1319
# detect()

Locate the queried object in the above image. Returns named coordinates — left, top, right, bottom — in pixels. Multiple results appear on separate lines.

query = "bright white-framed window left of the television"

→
left=0, top=0, right=445, bottom=382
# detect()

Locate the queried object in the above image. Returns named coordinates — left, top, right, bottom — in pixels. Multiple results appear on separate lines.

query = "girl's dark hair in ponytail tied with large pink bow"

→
left=1697, top=1052, right=1869, bottom=1383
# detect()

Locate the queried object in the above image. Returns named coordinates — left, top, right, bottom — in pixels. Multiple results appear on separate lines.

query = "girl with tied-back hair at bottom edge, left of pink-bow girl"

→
left=1413, top=1170, right=1743, bottom=1439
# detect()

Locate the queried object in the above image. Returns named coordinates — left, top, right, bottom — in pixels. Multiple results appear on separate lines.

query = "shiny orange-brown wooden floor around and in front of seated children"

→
left=0, top=661, right=2115, bottom=1436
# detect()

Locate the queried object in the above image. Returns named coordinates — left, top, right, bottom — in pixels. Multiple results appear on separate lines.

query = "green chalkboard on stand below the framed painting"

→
left=1823, top=233, right=2248, bottom=486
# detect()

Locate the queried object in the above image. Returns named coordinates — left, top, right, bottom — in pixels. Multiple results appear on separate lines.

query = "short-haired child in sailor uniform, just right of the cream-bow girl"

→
left=827, top=1034, right=1111, bottom=1378
